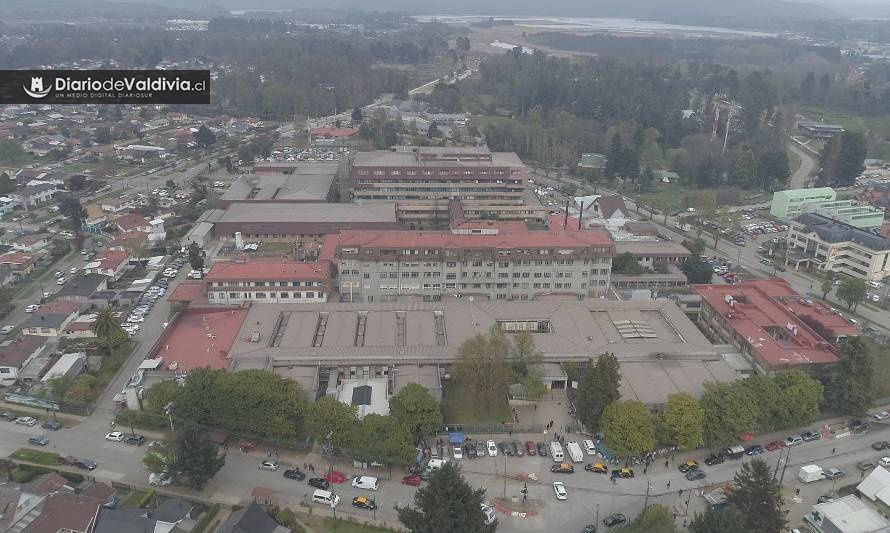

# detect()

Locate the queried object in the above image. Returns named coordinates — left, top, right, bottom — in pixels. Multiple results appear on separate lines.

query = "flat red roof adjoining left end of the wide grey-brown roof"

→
left=147, top=308, right=249, bottom=370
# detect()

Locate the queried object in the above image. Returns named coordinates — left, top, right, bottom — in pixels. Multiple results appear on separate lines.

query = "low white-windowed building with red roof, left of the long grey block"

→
left=204, top=260, right=331, bottom=304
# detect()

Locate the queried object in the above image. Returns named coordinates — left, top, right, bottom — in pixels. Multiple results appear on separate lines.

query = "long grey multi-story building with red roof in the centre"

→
left=330, top=222, right=615, bottom=302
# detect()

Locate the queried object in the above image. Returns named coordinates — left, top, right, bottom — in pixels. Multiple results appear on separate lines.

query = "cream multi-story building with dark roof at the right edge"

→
left=788, top=213, right=890, bottom=281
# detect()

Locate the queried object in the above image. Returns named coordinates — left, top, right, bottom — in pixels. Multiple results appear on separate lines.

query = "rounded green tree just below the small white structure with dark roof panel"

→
left=352, top=414, right=417, bottom=467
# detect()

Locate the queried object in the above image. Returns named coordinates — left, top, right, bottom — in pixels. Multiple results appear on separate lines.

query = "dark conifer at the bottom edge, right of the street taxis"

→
left=727, top=459, right=788, bottom=533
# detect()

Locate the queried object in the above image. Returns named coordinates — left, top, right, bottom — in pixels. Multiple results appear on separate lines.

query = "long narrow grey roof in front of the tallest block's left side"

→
left=217, top=203, right=396, bottom=223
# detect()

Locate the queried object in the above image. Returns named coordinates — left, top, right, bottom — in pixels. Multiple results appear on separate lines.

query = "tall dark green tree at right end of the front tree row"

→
left=825, top=337, right=875, bottom=416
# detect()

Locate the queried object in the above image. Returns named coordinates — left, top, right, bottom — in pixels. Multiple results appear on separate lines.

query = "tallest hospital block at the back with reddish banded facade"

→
left=340, top=146, right=549, bottom=227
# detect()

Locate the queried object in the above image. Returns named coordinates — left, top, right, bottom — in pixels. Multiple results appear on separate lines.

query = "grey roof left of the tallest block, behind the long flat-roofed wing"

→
left=222, top=163, right=339, bottom=202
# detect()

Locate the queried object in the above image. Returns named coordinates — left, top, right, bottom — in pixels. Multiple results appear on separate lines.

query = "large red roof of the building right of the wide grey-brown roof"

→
left=692, top=278, right=840, bottom=367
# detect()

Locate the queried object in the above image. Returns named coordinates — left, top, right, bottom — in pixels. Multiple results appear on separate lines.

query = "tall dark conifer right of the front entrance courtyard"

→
left=575, top=353, right=621, bottom=433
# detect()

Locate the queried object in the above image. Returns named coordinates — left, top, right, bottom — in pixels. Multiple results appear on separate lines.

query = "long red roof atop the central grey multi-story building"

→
left=339, top=224, right=612, bottom=249
